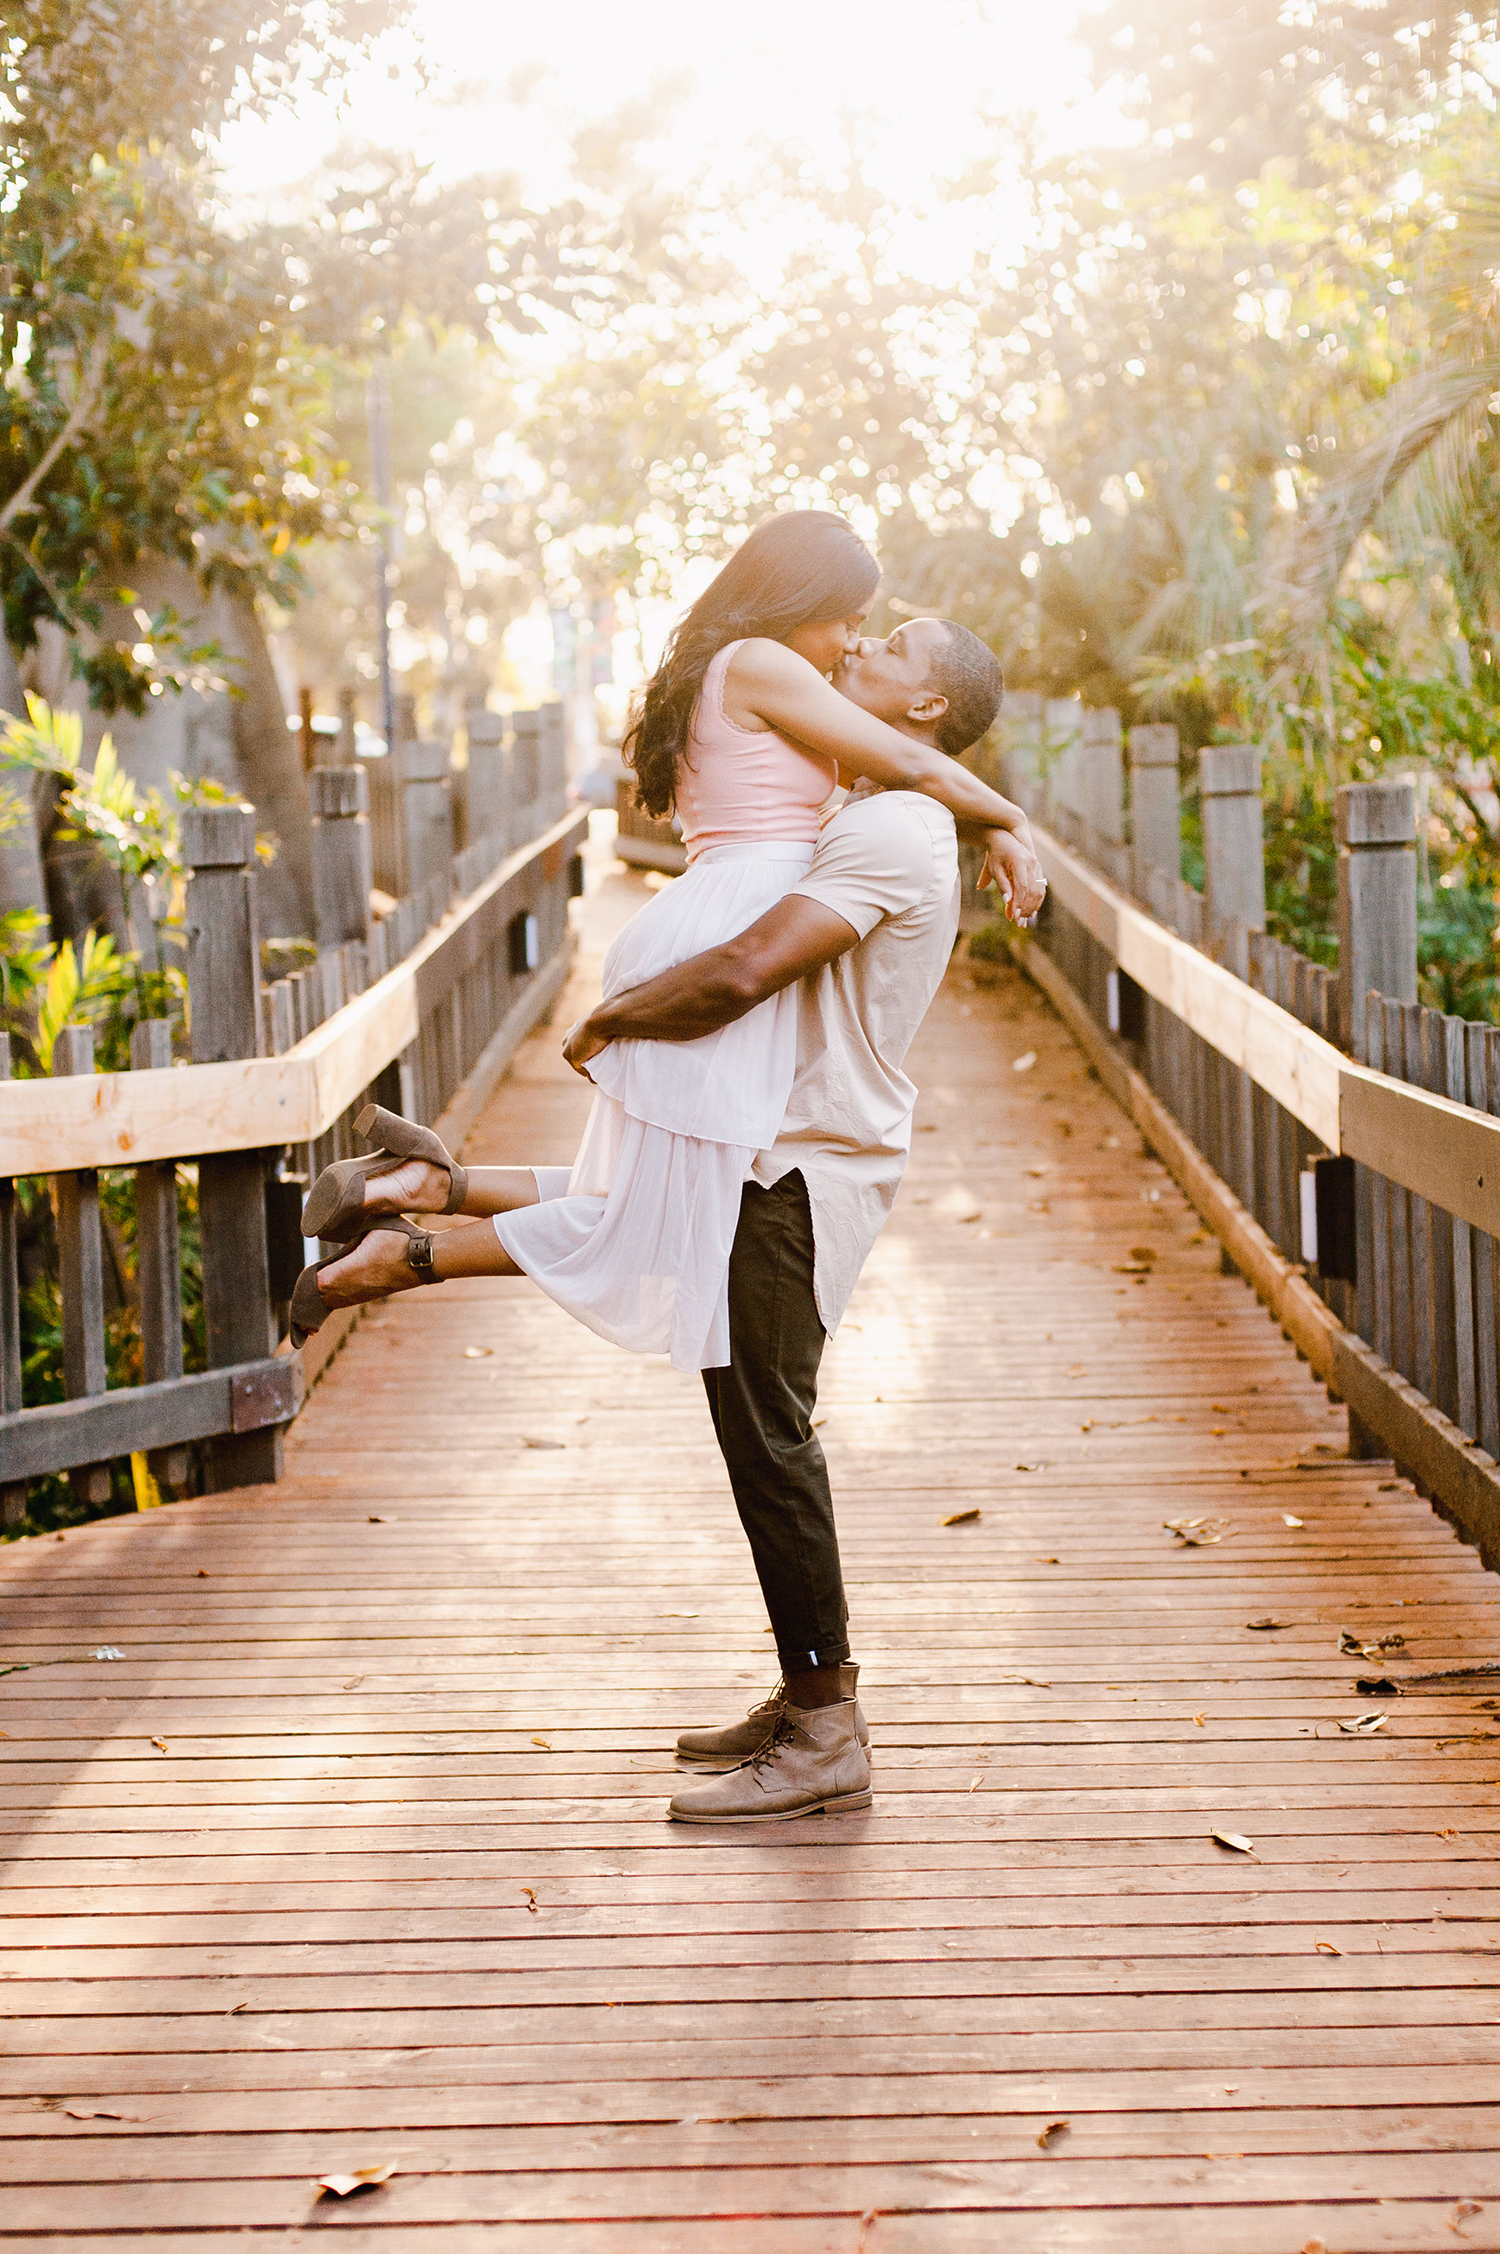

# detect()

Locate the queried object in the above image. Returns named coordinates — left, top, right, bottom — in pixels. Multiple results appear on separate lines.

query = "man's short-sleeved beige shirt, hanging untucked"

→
left=751, top=791, right=959, bottom=1334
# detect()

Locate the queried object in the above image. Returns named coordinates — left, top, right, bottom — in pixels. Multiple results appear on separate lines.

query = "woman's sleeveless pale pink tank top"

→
left=677, top=642, right=839, bottom=861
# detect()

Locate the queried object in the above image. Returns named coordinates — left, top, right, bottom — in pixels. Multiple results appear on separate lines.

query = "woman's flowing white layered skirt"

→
left=494, top=841, right=812, bottom=1370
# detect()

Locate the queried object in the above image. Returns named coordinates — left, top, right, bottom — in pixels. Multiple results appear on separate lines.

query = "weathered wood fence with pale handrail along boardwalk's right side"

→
left=1002, top=694, right=1500, bottom=1564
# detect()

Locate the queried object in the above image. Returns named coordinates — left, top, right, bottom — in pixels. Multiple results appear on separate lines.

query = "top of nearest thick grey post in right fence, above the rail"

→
left=1333, top=782, right=1417, bottom=1062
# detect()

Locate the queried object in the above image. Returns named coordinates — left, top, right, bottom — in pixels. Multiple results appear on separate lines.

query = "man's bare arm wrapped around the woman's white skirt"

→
left=562, top=893, right=859, bottom=1077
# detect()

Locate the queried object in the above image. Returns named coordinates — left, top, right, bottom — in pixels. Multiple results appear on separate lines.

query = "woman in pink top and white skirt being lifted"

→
left=293, top=509, right=1042, bottom=1368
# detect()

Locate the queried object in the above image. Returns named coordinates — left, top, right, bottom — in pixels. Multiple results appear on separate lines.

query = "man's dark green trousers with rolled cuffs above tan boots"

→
left=704, top=1174, right=848, bottom=1670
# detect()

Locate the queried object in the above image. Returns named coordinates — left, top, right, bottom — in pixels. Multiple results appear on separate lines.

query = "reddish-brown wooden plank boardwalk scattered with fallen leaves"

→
left=0, top=852, right=1500, bottom=2254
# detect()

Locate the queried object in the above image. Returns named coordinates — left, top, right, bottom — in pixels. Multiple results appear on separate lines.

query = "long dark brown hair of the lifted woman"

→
left=623, top=509, right=880, bottom=816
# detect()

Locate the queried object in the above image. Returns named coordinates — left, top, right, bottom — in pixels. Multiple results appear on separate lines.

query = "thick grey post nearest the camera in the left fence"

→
left=183, top=807, right=282, bottom=1490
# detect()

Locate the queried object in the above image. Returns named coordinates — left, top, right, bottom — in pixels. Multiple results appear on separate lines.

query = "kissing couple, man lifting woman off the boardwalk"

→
left=291, top=509, right=1047, bottom=1823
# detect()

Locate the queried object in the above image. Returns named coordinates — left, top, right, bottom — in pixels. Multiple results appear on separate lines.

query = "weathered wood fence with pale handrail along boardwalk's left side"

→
left=0, top=708, right=586, bottom=1524
